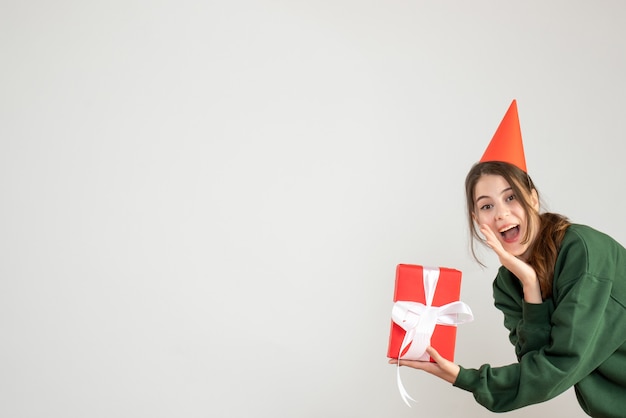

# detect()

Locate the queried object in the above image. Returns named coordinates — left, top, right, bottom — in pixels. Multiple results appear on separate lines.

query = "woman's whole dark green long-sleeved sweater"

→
left=454, top=224, right=626, bottom=417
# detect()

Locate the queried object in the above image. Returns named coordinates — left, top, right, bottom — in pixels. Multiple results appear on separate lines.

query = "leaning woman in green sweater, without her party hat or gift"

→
left=390, top=102, right=626, bottom=417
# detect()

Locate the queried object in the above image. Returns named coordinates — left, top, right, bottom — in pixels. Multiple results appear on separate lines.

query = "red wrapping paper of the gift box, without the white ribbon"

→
left=387, top=264, right=464, bottom=362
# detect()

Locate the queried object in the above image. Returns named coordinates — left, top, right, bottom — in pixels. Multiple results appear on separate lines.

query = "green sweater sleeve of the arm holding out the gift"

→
left=454, top=233, right=626, bottom=412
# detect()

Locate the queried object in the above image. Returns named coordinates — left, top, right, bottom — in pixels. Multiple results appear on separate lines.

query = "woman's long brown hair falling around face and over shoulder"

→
left=465, top=161, right=571, bottom=299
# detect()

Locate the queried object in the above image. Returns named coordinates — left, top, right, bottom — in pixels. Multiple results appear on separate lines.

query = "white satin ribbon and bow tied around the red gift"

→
left=391, top=267, right=474, bottom=407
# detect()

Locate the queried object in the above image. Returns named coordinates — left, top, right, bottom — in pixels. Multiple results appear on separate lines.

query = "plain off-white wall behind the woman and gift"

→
left=0, top=0, right=626, bottom=418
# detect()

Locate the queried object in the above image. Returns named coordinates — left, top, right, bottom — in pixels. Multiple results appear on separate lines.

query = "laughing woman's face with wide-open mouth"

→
left=473, top=174, right=539, bottom=260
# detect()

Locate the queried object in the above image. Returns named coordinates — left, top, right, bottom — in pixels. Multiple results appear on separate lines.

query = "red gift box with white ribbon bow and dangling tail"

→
left=387, top=264, right=474, bottom=406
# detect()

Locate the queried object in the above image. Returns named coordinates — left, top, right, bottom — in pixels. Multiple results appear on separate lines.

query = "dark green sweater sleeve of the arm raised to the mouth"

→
left=493, top=271, right=552, bottom=360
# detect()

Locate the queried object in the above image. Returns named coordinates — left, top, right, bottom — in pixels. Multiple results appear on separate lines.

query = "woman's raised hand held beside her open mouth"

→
left=480, top=225, right=543, bottom=303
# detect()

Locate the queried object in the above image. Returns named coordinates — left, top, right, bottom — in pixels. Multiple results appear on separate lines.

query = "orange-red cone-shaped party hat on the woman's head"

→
left=480, top=100, right=527, bottom=173
